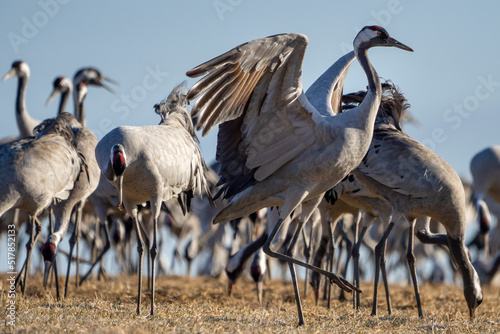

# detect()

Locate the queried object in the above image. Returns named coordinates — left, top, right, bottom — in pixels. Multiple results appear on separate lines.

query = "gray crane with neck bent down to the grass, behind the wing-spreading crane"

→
left=348, top=82, right=483, bottom=317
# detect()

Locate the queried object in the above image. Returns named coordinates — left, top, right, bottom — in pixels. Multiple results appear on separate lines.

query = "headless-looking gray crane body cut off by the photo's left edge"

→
left=0, top=113, right=86, bottom=294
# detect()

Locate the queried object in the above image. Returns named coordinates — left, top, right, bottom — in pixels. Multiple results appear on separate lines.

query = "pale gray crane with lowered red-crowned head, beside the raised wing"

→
left=95, top=86, right=209, bottom=314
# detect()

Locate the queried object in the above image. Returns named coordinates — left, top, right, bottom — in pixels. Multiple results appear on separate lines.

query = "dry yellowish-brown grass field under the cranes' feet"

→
left=0, top=275, right=500, bottom=333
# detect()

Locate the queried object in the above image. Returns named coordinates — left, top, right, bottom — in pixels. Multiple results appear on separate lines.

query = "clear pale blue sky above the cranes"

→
left=0, top=0, right=500, bottom=183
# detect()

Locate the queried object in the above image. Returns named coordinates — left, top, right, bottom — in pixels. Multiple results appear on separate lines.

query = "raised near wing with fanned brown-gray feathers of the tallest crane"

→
left=187, top=34, right=322, bottom=197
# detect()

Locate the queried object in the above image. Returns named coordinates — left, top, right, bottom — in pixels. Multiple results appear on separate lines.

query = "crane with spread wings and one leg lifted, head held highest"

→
left=186, top=26, right=412, bottom=324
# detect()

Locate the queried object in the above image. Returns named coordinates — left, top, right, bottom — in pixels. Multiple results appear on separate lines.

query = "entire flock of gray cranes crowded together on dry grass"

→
left=0, top=26, right=500, bottom=325
